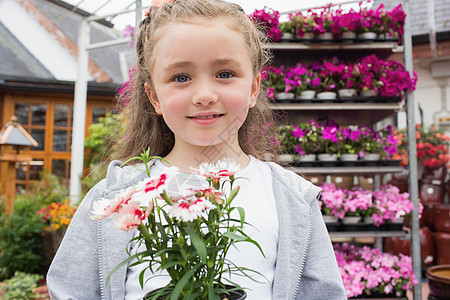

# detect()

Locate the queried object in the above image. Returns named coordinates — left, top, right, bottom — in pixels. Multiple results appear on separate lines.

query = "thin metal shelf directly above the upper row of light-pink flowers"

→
left=287, top=166, right=403, bottom=175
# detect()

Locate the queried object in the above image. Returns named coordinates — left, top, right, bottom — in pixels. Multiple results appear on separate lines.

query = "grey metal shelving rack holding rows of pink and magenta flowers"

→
left=269, top=0, right=422, bottom=300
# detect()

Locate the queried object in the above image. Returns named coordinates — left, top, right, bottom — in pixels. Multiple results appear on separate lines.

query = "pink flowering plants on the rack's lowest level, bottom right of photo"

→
left=334, top=243, right=418, bottom=299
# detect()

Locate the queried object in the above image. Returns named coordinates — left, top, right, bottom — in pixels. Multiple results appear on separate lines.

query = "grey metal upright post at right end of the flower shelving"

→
left=403, top=0, right=422, bottom=300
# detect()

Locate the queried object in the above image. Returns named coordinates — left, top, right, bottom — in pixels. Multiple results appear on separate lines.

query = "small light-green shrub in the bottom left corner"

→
left=2, top=272, right=43, bottom=300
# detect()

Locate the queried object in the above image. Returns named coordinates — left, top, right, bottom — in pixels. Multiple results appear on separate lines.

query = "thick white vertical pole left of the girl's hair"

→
left=70, top=19, right=90, bottom=203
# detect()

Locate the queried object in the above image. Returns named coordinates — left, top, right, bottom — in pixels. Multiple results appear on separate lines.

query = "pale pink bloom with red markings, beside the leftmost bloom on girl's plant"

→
left=114, top=200, right=148, bottom=231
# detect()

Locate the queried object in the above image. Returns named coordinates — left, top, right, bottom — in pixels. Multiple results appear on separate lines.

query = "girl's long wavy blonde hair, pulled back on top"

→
left=117, top=0, right=274, bottom=164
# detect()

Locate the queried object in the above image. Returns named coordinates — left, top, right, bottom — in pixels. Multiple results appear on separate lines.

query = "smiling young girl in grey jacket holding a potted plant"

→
left=47, top=0, right=346, bottom=300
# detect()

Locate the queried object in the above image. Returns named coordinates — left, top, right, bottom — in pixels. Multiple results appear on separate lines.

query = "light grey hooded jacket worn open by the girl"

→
left=47, top=161, right=347, bottom=300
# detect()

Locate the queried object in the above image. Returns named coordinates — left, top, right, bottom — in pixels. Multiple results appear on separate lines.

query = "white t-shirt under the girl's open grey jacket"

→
left=125, top=157, right=278, bottom=300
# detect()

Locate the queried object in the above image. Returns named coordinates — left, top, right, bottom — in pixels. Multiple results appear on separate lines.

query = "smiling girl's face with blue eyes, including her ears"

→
left=145, top=20, right=260, bottom=151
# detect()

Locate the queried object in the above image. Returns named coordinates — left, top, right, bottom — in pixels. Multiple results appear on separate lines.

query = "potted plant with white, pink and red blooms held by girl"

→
left=92, top=150, right=262, bottom=299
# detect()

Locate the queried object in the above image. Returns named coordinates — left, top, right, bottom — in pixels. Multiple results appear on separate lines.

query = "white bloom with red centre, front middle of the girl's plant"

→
left=168, top=196, right=216, bottom=222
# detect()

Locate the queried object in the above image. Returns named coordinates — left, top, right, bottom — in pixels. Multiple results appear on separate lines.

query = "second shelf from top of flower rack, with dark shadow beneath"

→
left=271, top=102, right=403, bottom=125
